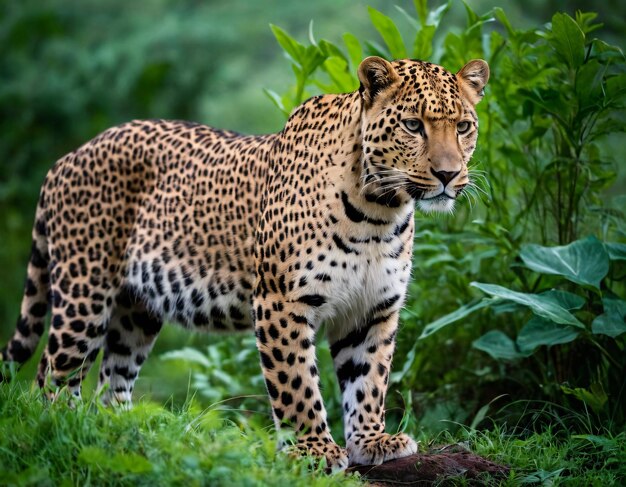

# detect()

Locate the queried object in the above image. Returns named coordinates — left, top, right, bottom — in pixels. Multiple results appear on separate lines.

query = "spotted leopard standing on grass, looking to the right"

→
left=1, top=56, right=489, bottom=470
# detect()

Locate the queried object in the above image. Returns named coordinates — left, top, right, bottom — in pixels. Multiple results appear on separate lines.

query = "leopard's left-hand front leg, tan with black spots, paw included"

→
left=254, top=295, right=348, bottom=470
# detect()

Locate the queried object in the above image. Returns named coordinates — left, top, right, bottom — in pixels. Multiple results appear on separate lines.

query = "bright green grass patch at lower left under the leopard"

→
left=0, top=383, right=361, bottom=486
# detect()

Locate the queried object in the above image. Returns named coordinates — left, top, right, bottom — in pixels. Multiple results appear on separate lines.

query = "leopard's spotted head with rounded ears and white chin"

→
left=358, top=57, right=489, bottom=212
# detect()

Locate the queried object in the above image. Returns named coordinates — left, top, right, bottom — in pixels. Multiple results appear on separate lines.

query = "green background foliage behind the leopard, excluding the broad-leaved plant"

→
left=0, top=0, right=626, bottom=452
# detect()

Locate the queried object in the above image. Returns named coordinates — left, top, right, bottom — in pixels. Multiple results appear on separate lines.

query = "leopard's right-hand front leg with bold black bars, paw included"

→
left=329, top=305, right=417, bottom=465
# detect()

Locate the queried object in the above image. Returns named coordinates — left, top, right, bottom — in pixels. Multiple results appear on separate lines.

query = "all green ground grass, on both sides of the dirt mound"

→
left=0, top=381, right=626, bottom=486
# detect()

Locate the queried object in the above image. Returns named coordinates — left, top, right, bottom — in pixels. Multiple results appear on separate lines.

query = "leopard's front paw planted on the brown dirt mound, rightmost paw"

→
left=347, top=432, right=417, bottom=465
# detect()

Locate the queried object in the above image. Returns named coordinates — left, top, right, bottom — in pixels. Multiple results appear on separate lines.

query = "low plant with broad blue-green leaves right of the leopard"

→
left=421, top=237, right=626, bottom=423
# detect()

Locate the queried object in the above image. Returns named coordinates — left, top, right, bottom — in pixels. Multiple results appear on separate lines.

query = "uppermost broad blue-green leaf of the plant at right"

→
left=520, top=236, right=609, bottom=289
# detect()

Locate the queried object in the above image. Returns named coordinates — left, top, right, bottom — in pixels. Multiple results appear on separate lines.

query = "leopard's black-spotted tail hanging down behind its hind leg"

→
left=0, top=190, right=50, bottom=374
